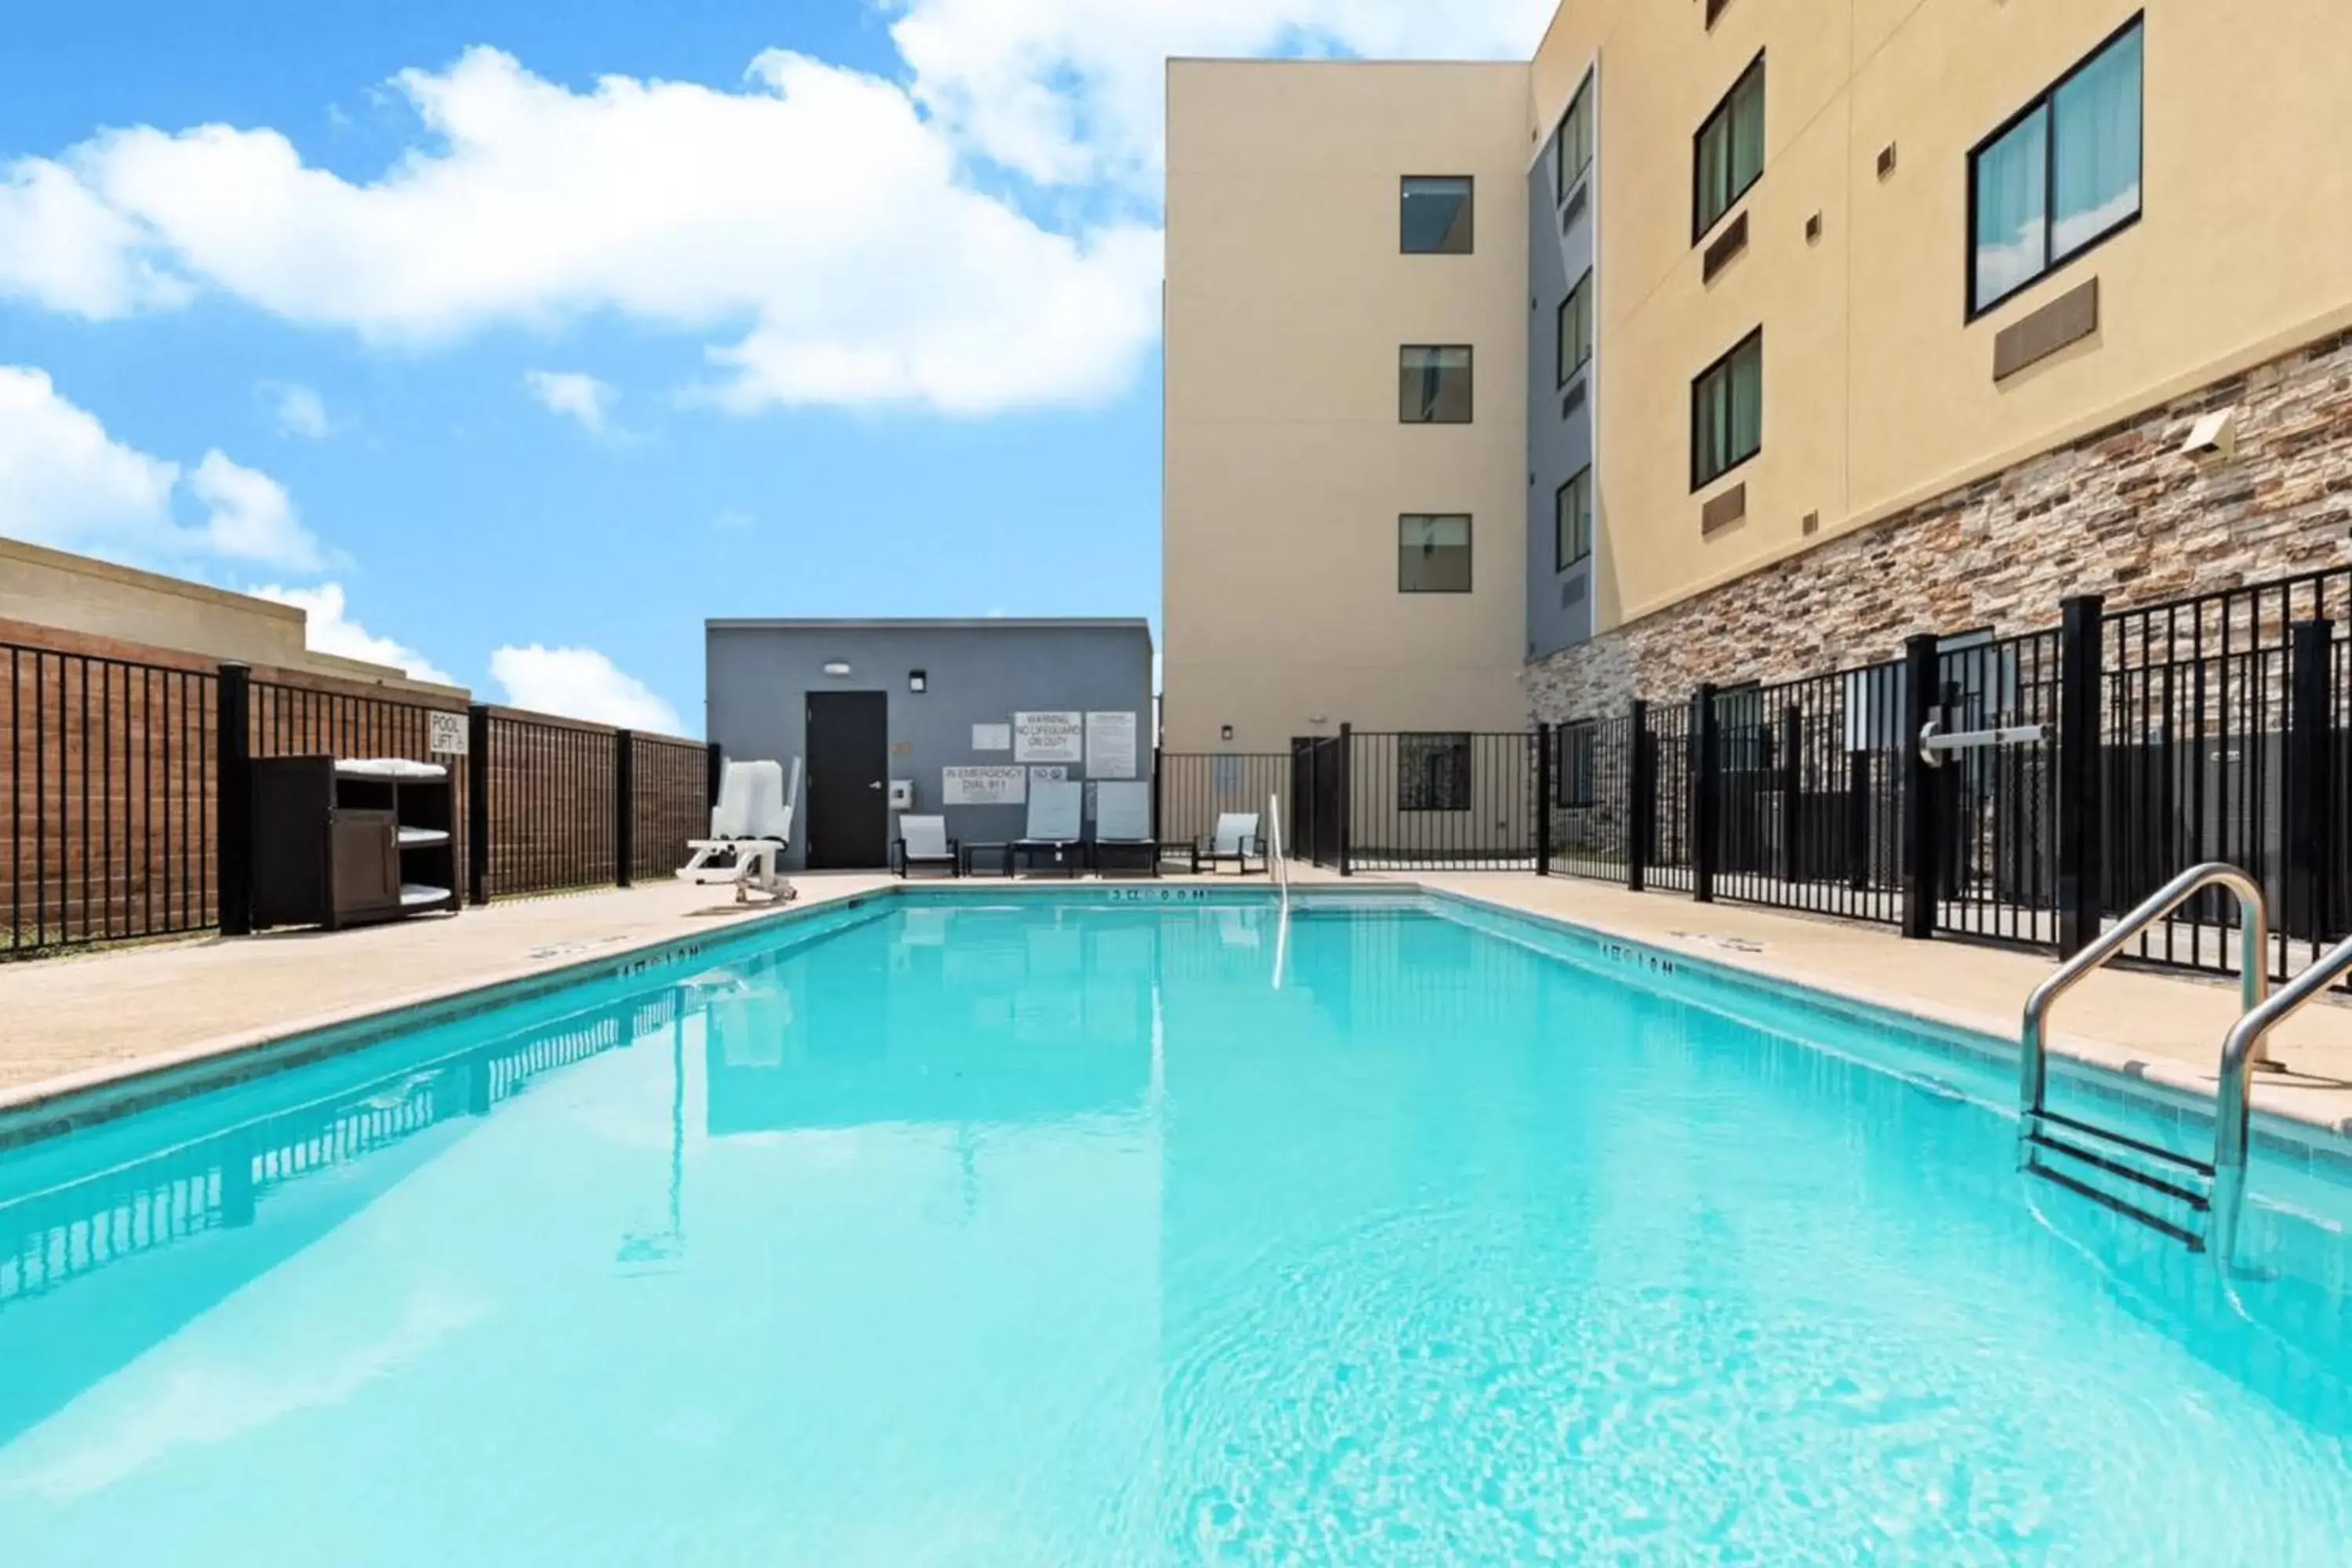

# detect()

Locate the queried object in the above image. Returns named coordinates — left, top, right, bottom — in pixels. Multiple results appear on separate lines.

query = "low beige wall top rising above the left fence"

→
left=0, top=539, right=466, bottom=701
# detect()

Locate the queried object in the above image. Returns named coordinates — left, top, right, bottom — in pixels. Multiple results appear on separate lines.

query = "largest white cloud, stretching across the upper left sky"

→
left=0, top=49, right=1160, bottom=414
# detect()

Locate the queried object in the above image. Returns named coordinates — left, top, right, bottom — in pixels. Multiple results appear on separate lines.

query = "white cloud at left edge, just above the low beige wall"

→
left=0, top=365, right=327, bottom=572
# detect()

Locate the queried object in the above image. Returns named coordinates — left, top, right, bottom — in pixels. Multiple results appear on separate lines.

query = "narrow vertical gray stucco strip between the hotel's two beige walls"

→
left=1526, top=73, right=1599, bottom=659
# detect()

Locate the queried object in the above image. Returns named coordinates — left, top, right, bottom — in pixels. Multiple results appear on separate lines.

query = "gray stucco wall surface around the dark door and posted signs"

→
left=703, top=621, right=1152, bottom=867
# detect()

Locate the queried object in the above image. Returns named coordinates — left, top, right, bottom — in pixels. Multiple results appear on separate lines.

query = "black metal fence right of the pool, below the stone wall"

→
left=1291, top=567, right=2352, bottom=978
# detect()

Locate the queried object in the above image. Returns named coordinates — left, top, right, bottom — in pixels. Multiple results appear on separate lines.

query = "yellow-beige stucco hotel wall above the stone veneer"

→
left=1529, top=0, right=2352, bottom=628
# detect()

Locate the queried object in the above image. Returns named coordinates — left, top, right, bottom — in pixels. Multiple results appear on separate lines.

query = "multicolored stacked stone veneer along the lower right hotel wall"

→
left=1526, top=332, right=2352, bottom=724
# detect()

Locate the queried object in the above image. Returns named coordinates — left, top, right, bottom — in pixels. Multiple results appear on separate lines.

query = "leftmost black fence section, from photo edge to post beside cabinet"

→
left=0, top=644, right=216, bottom=954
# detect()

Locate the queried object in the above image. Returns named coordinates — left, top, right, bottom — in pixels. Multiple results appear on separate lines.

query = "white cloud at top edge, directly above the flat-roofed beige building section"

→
left=891, top=0, right=1557, bottom=183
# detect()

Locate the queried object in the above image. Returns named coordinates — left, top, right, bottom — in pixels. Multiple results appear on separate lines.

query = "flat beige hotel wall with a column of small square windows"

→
left=1162, top=61, right=1531, bottom=753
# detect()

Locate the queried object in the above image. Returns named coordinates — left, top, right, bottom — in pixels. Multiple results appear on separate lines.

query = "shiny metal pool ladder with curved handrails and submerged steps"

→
left=2018, top=860, right=2267, bottom=1267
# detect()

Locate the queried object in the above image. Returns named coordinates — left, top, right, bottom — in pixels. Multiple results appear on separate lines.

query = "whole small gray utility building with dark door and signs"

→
left=703, top=619, right=1155, bottom=869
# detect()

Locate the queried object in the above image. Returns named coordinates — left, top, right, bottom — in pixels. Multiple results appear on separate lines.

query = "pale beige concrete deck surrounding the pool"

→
left=0, top=867, right=2352, bottom=1131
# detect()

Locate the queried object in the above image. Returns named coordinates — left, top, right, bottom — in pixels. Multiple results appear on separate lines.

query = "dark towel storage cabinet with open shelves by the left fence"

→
left=252, top=757, right=456, bottom=931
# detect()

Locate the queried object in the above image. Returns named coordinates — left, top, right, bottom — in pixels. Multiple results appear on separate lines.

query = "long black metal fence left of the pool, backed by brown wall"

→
left=0, top=644, right=715, bottom=956
